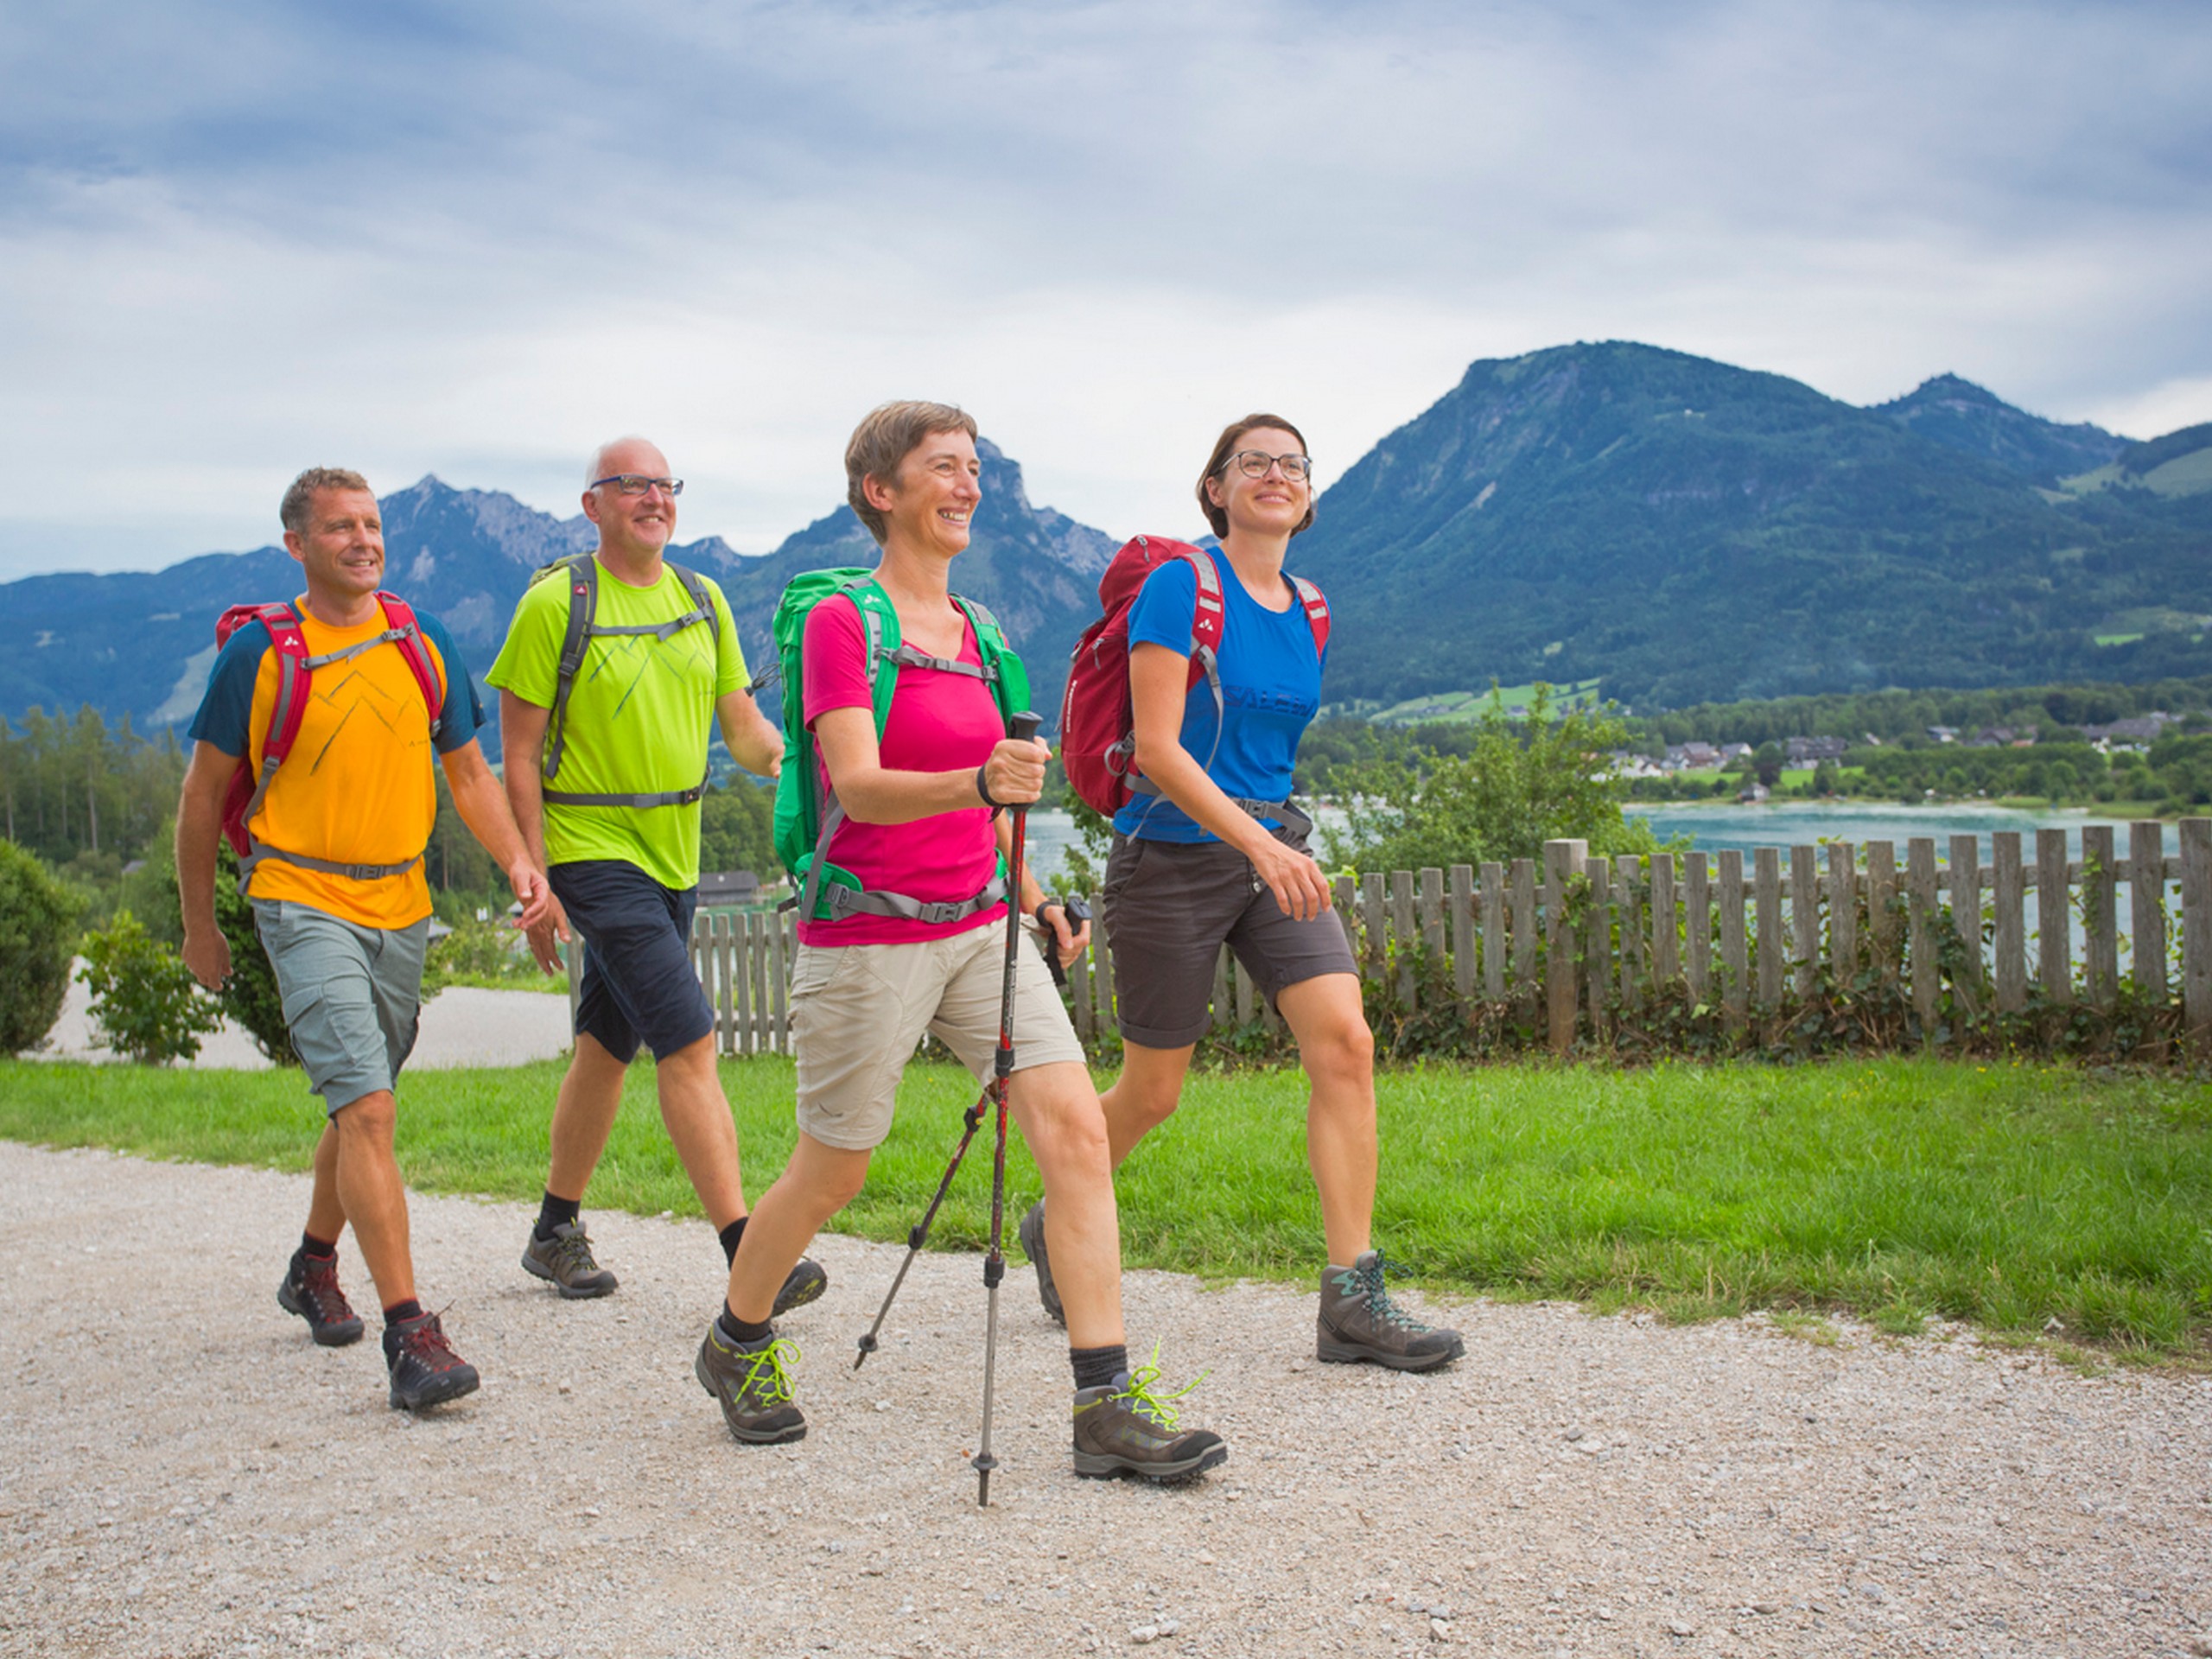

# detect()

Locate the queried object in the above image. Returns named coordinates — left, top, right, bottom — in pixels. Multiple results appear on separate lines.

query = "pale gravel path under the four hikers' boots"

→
left=0, top=1146, right=2212, bottom=1659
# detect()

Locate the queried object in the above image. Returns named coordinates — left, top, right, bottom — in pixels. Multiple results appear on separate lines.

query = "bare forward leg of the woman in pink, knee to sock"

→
left=1013, top=1062, right=1123, bottom=1347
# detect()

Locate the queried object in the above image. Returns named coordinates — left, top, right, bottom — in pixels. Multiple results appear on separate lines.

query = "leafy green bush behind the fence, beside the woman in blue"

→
left=1323, top=686, right=1659, bottom=869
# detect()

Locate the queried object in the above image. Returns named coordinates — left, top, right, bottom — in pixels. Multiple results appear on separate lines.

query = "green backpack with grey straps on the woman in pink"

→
left=774, top=566, right=1028, bottom=923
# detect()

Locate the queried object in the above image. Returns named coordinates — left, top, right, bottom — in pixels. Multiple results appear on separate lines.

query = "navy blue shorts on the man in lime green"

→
left=546, top=858, right=715, bottom=1066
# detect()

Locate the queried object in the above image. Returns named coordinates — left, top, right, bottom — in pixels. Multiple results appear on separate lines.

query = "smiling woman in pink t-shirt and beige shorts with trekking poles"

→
left=699, top=403, right=1228, bottom=1480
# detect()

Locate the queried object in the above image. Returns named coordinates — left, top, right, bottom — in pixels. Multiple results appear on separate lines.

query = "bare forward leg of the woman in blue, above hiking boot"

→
left=1276, top=973, right=1376, bottom=1268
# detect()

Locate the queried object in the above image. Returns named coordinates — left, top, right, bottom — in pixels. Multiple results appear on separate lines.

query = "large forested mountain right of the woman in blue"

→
left=1294, top=343, right=2212, bottom=706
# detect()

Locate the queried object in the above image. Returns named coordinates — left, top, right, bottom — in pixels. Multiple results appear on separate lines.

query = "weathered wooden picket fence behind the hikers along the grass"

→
left=570, top=818, right=2212, bottom=1058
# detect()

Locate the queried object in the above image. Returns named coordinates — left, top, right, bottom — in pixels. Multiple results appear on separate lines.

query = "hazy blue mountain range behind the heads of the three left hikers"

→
left=0, top=442, right=1115, bottom=747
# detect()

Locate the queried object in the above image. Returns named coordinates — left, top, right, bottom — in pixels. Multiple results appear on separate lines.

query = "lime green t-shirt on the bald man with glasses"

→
left=485, top=562, right=752, bottom=889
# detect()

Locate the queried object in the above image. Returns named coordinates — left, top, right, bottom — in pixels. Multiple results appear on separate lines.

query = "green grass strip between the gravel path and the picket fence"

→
left=0, top=1058, right=2212, bottom=1358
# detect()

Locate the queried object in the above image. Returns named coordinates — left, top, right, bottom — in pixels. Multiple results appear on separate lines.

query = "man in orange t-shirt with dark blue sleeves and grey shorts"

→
left=177, top=467, right=546, bottom=1411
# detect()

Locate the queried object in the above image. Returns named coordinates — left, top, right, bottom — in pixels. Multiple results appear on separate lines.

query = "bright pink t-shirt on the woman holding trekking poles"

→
left=798, top=595, right=1007, bottom=944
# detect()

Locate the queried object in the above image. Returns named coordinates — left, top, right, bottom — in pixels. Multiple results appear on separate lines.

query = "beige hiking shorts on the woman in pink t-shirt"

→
left=791, top=923, right=1084, bottom=1153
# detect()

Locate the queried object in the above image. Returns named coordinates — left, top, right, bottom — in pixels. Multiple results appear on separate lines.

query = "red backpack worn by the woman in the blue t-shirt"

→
left=1059, top=536, right=1330, bottom=818
